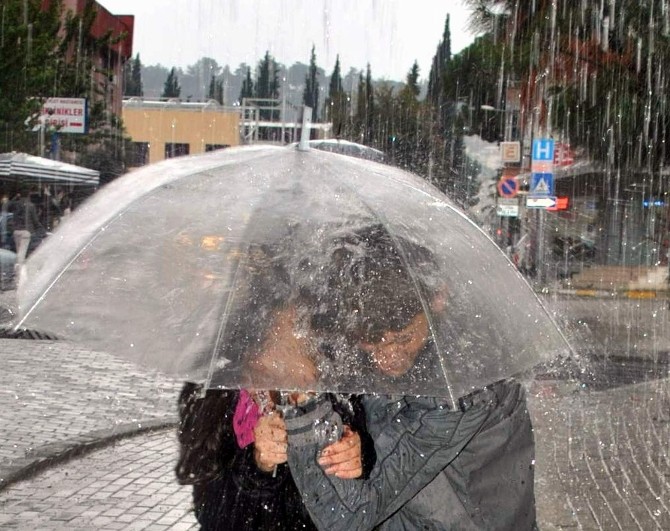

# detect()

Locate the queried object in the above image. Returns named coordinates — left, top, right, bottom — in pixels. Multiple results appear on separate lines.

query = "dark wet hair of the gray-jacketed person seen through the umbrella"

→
left=311, top=224, right=435, bottom=343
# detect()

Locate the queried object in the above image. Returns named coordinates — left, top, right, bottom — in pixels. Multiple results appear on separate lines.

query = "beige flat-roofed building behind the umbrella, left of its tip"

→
left=123, top=98, right=241, bottom=166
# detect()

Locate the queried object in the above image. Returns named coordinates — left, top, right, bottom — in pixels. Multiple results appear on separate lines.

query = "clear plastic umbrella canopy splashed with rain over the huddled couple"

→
left=17, top=143, right=569, bottom=398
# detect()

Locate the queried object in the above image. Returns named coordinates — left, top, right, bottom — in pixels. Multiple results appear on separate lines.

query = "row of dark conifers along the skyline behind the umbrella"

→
left=126, top=16, right=488, bottom=204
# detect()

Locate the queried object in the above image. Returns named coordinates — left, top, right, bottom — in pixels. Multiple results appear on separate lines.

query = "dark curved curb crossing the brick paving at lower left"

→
left=0, top=417, right=178, bottom=492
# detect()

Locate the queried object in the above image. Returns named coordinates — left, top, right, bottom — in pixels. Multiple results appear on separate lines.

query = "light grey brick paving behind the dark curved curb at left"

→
left=0, top=339, right=181, bottom=489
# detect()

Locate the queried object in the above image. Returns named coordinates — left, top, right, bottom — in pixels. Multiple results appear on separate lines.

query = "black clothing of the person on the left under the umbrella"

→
left=176, top=384, right=374, bottom=531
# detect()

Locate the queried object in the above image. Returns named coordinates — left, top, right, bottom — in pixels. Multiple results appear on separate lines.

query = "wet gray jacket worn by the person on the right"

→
left=286, top=381, right=535, bottom=531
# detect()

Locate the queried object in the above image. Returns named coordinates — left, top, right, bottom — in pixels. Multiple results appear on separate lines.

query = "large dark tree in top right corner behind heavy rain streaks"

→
left=466, top=0, right=670, bottom=170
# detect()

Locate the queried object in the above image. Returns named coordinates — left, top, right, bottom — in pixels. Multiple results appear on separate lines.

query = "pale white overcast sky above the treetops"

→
left=98, top=0, right=474, bottom=80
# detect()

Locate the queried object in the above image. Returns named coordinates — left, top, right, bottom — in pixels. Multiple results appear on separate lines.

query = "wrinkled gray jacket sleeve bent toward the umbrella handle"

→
left=287, top=397, right=490, bottom=531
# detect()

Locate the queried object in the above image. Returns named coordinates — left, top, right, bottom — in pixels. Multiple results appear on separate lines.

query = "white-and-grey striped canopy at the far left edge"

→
left=0, top=153, right=100, bottom=186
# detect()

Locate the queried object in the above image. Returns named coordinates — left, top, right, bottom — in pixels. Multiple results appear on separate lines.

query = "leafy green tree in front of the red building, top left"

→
left=0, top=0, right=135, bottom=183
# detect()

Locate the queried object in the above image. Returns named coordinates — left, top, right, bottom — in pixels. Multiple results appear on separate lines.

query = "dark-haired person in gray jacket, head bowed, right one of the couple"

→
left=286, top=226, right=535, bottom=530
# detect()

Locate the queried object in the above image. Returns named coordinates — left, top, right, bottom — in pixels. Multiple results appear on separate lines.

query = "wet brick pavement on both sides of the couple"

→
left=0, top=286, right=670, bottom=531
